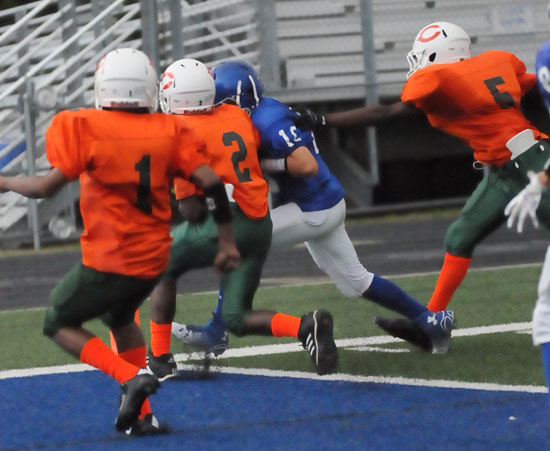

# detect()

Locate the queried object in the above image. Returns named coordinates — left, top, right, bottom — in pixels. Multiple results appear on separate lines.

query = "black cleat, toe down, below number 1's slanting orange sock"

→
left=115, top=370, right=160, bottom=431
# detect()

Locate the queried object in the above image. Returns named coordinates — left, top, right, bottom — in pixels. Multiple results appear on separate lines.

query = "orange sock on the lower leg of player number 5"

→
left=428, top=252, right=472, bottom=312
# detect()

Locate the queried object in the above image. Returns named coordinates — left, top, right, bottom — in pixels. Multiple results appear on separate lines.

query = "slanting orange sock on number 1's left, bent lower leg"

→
left=80, top=337, right=139, bottom=384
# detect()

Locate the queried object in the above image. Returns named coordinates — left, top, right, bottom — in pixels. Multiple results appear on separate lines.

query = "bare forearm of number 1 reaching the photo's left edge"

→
left=0, top=168, right=69, bottom=199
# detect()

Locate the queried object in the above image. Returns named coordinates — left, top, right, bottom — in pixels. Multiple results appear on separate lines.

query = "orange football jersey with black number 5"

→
left=401, top=50, right=546, bottom=166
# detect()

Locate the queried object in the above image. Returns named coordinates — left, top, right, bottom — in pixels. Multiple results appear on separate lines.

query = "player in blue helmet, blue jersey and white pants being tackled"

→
left=172, top=61, right=454, bottom=353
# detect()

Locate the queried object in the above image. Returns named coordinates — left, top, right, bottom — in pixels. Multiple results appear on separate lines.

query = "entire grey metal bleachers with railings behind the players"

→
left=0, top=0, right=550, bottom=247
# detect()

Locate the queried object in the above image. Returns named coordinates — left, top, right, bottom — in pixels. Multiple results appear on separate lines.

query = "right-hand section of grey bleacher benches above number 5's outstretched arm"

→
left=277, top=0, right=550, bottom=101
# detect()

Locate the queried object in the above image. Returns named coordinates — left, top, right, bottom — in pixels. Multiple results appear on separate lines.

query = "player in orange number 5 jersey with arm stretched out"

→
left=297, top=22, right=550, bottom=352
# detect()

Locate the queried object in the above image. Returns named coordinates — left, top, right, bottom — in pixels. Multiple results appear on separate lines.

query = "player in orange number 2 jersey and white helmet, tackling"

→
left=148, top=59, right=338, bottom=378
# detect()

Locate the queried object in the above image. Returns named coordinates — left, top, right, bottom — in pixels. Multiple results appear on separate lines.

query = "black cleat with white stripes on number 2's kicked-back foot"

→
left=298, top=310, right=338, bottom=376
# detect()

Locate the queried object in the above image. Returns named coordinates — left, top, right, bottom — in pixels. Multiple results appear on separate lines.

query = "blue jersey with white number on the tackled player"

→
left=251, top=97, right=344, bottom=211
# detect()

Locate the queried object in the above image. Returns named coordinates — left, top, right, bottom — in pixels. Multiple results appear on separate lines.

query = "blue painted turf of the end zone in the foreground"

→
left=0, top=371, right=550, bottom=451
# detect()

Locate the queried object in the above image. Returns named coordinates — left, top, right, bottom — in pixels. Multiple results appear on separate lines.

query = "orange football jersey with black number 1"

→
left=46, top=109, right=208, bottom=278
